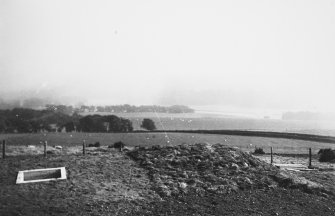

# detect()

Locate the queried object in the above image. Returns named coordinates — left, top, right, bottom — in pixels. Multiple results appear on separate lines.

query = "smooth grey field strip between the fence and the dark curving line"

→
left=0, top=133, right=335, bottom=154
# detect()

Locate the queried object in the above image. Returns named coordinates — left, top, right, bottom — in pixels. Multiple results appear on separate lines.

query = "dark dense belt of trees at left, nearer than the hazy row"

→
left=0, top=108, right=133, bottom=133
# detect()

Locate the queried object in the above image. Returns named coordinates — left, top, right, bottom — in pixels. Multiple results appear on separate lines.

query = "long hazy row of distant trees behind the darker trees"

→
left=46, top=104, right=194, bottom=114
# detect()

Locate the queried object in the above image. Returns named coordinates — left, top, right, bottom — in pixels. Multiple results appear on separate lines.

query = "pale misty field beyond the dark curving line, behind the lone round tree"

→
left=84, top=113, right=335, bottom=136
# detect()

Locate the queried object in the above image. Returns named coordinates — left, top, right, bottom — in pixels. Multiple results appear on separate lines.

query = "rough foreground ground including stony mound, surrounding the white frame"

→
left=0, top=143, right=335, bottom=215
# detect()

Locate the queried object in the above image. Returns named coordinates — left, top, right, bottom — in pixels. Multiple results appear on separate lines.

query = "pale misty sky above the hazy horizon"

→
left=0, top=0, right=335, bottom=112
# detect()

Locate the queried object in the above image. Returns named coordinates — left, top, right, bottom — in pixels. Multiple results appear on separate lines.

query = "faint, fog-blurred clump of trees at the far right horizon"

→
left=282, top=112, right=335, bottom=121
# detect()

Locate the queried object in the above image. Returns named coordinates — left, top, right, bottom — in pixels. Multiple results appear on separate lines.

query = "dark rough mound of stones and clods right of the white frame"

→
left=128, top=143, right=279, bottom=196
